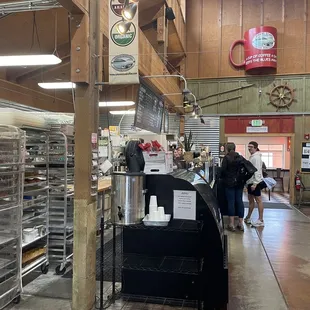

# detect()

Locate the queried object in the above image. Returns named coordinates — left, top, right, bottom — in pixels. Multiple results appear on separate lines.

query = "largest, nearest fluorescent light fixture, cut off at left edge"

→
left=0, top=55, right=61, bottom=67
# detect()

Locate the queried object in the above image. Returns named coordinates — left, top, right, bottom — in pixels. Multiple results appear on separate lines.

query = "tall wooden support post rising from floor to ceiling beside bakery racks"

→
left=71, top=1, right=100, bottom=310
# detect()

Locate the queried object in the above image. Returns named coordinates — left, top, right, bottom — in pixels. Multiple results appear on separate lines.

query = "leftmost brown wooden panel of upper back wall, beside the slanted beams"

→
left=186, top=0, right=202, bottom=78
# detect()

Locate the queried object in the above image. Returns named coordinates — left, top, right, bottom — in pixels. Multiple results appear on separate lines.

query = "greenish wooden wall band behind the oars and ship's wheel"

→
left=189, top=75, right=310, bottom=114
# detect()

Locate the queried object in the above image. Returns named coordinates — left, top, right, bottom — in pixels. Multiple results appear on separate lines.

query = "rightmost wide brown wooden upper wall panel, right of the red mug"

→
left=283, top=0, right=306, bottom=73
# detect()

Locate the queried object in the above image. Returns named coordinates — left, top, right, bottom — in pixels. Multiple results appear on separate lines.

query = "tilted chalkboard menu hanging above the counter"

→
left=134, top=83, right=164, bottom=134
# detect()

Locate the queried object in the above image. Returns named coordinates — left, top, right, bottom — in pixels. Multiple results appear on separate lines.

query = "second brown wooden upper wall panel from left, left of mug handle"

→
left=198, top=0, right=222, bottom=77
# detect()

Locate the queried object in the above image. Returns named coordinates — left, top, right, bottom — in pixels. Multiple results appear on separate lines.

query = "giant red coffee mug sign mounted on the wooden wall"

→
left=229, top=26, right=277, bottom=71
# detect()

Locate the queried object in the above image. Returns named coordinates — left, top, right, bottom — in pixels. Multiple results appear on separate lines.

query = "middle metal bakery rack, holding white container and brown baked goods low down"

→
left=22, top=127, right=49, bottom=277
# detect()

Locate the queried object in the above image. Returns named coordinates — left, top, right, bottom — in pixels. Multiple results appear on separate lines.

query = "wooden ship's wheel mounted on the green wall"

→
left=266, top=83, right=296, bottom=111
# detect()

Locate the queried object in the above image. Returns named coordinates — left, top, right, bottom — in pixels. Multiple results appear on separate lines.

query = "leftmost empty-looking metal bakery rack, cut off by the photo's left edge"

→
left=0, top=125, right=25, bottom=309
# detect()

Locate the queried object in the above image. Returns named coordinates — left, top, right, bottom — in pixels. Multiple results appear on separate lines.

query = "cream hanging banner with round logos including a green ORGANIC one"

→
left=109, top=0, right=139, bottom=84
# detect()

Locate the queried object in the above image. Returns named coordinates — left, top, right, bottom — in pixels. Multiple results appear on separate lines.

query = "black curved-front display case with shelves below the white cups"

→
left=122, top=170, right=228, bottom=309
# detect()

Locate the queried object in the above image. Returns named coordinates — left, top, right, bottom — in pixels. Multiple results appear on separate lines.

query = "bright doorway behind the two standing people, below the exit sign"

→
left=226, top=135, right=293, bottom=205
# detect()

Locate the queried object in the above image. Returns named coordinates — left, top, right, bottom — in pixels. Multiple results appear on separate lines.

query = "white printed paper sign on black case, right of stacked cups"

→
left=173, top=190, right=196, bottom=220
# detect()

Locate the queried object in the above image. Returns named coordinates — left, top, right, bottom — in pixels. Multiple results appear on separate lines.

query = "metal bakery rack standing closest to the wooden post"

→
left=49, top=125, right=74, bottom=275
